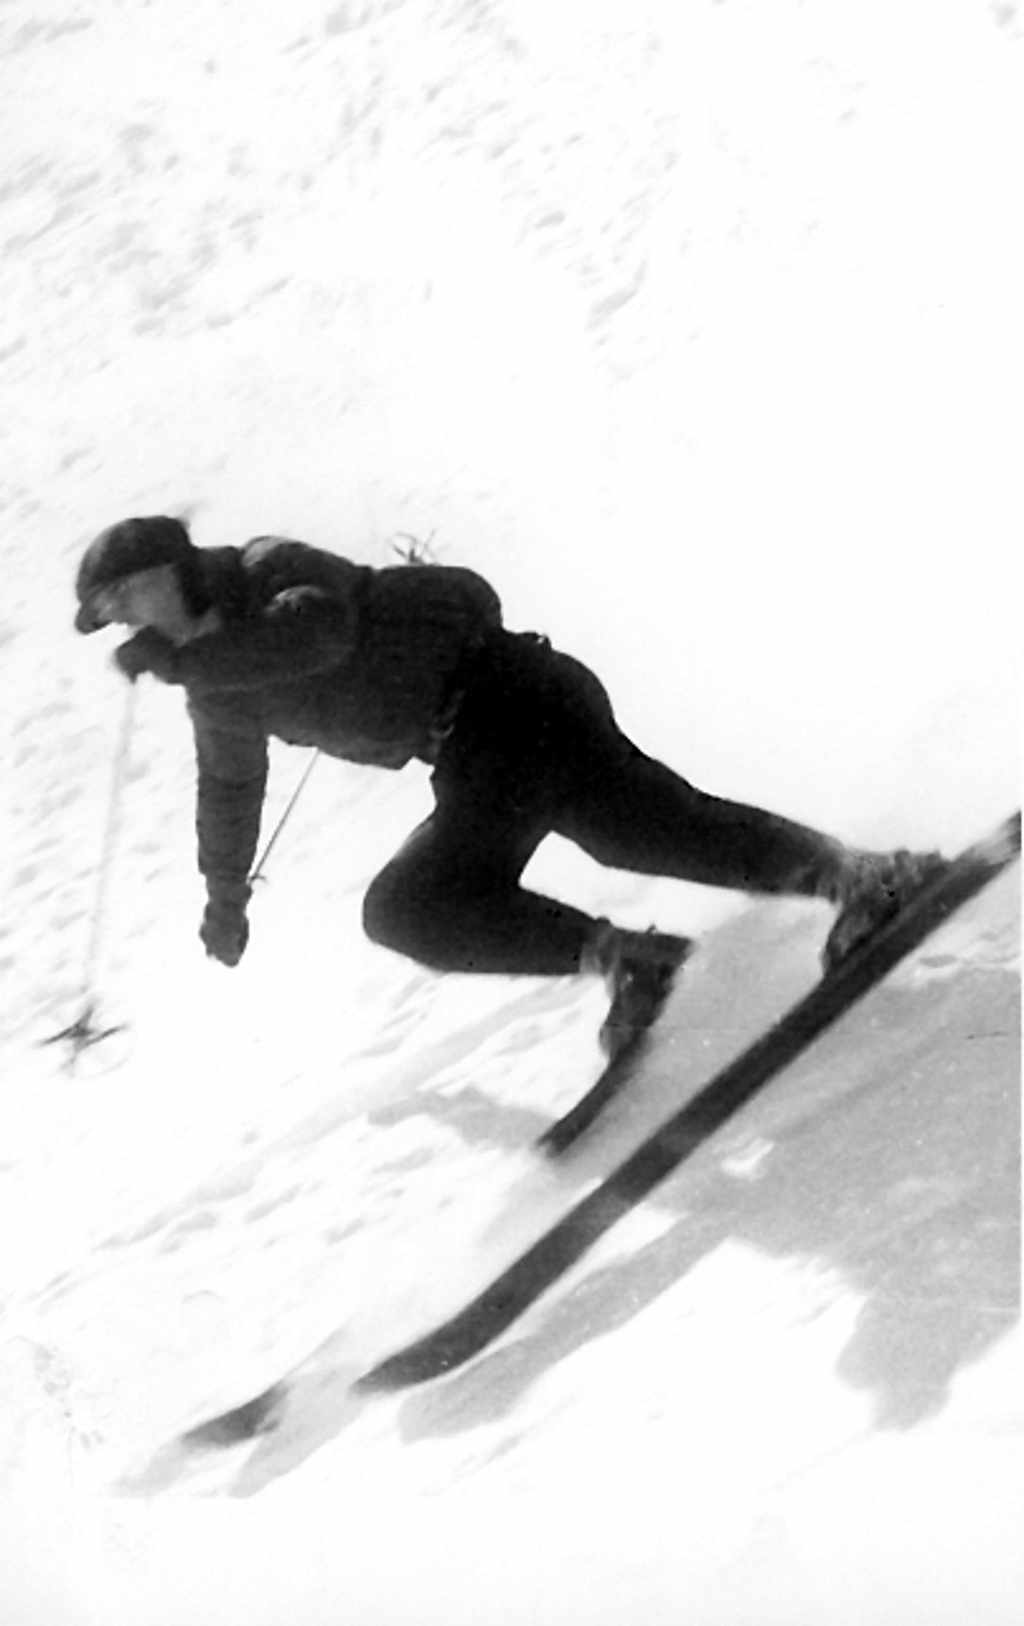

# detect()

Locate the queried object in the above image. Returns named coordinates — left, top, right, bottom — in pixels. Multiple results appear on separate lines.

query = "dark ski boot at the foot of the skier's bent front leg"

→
left=584, top=920, right=694, bottom=1062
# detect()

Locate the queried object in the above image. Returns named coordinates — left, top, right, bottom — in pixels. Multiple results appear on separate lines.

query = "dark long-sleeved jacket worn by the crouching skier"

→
left=177, top=537, right=501, bottom=893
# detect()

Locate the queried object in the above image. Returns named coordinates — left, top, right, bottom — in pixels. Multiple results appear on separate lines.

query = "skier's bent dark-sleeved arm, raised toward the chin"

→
left=176, top=587, right=356, bottom=694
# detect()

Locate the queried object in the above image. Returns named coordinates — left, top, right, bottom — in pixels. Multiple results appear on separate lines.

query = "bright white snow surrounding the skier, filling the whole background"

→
left=0, top=0, right=1024, bottom=1626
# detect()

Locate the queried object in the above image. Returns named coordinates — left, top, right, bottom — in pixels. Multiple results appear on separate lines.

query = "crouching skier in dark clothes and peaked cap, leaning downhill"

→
left=75, top=515, right=941, bottom=1057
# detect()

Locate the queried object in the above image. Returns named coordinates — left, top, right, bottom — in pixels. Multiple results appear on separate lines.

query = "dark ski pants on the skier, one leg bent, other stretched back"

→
left=362, top=633, right=844, bottom=976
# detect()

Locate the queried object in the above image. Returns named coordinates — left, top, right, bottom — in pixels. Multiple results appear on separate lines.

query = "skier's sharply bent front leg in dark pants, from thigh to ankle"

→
left=362, top=808, right=597, bottom=976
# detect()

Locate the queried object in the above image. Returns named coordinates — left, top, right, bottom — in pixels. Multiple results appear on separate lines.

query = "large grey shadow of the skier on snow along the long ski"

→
left=391, top=893, right=1019, bottom=1441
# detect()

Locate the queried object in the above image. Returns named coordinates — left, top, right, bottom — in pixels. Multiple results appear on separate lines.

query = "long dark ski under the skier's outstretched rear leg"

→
left=354, top=811, right=1021, bottom=1392
